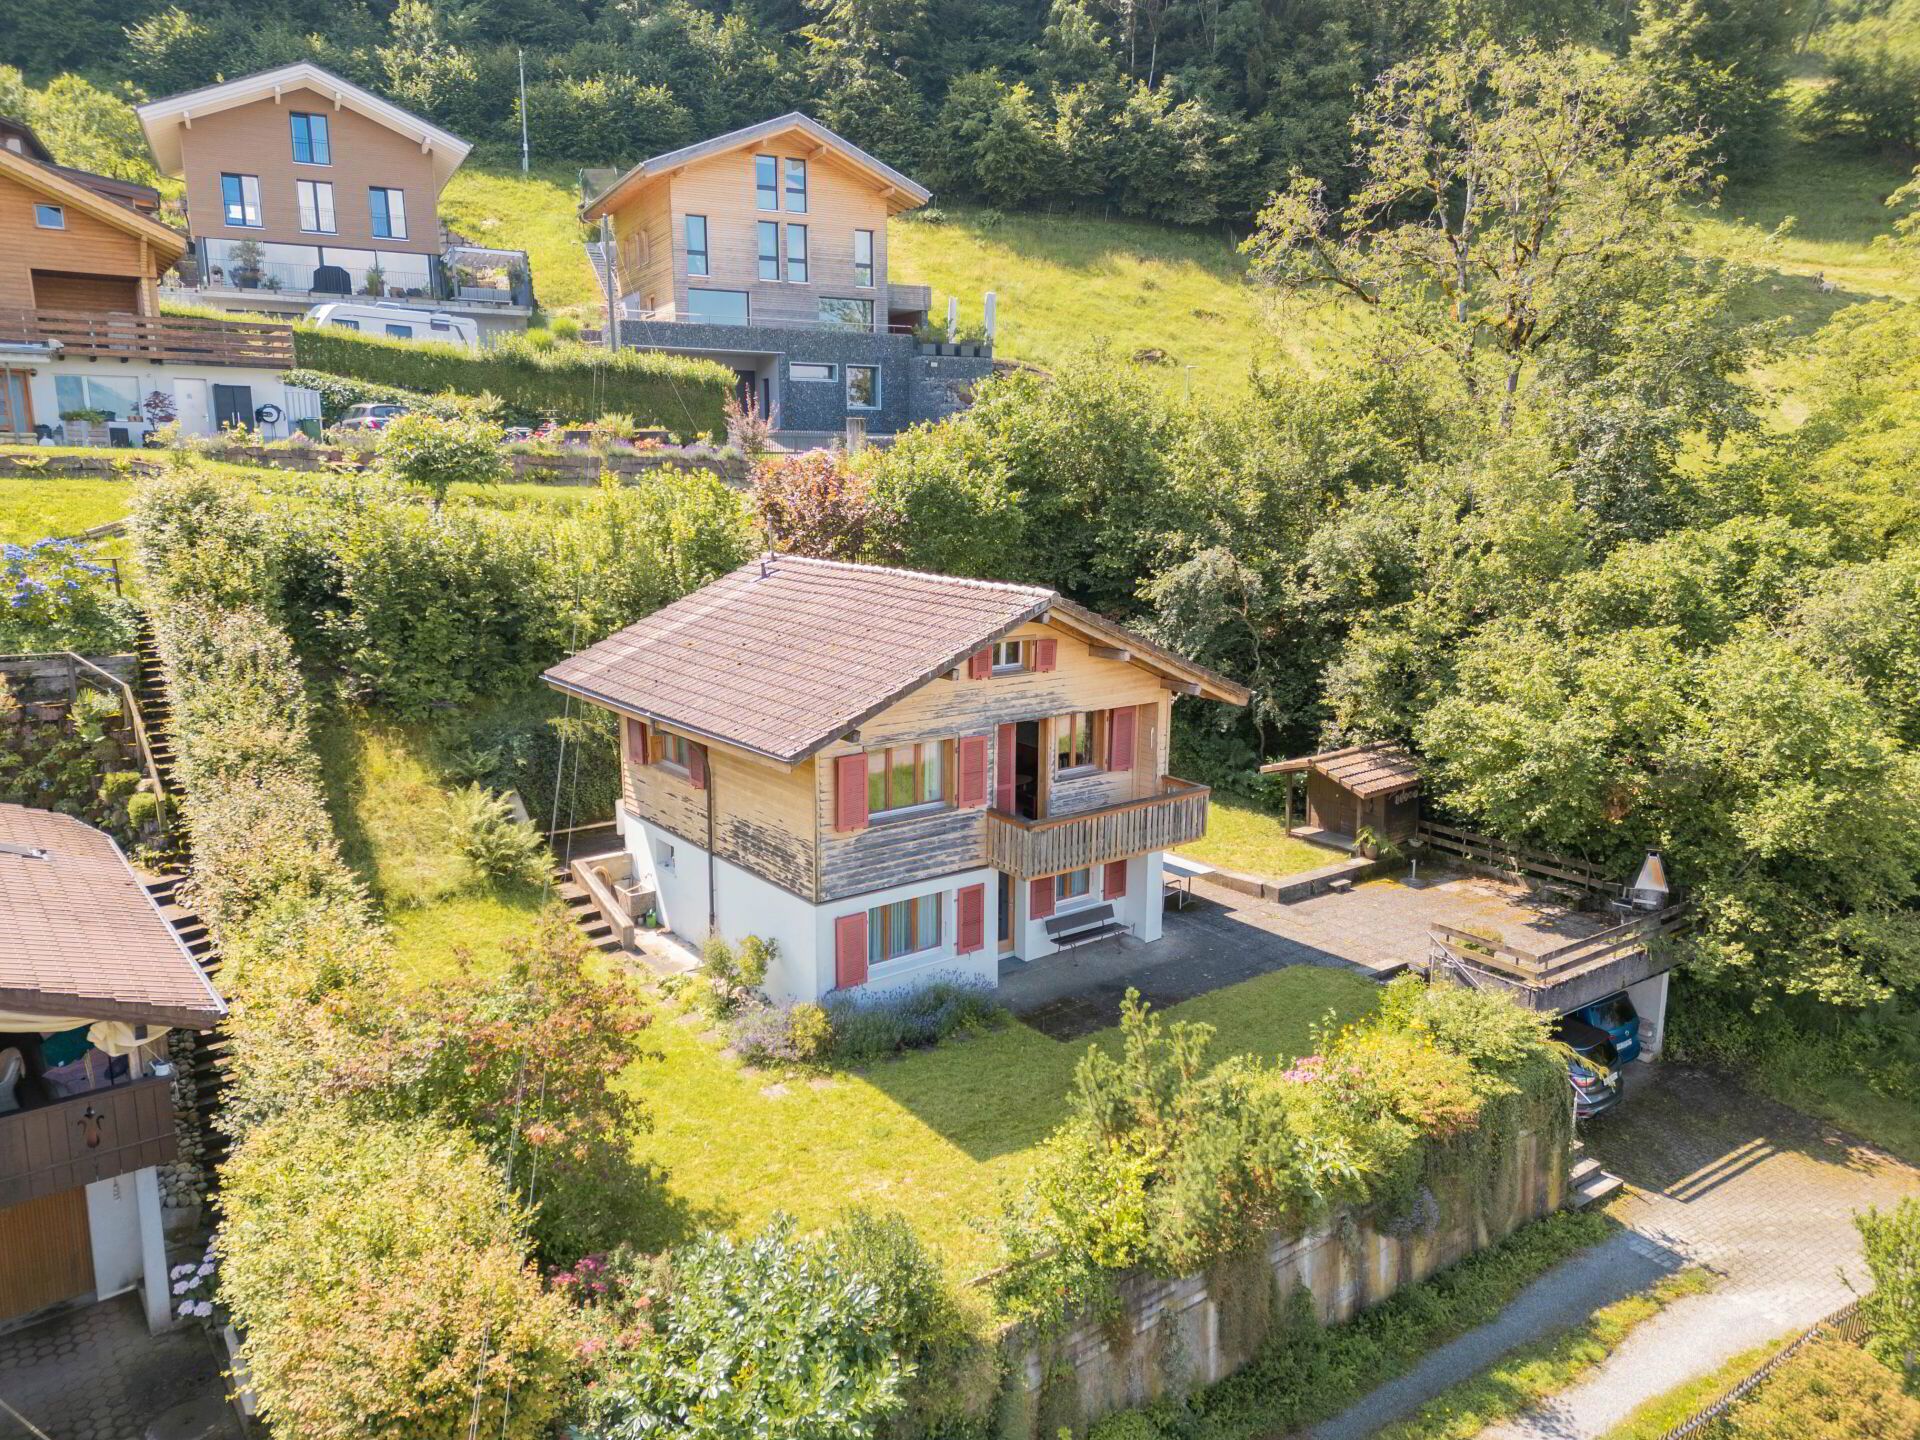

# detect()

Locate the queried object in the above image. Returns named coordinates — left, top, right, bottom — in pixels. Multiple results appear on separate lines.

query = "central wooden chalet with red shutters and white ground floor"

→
left=545, top=555, right=1248, bottom=1000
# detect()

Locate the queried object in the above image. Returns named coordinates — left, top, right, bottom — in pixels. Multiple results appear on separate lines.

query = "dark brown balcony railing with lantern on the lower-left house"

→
left=0, top=1079, right=180, bottom=1210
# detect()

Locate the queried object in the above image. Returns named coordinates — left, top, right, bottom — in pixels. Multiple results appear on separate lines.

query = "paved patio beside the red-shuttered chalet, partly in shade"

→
left=1000, top=872, right=1611, bottom=1041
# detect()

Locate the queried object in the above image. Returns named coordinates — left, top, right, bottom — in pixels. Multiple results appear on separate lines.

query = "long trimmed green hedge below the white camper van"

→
left=294, top=324, right=733, bottom=436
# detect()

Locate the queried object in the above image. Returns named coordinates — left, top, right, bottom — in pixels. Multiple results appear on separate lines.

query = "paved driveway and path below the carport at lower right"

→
left=1309, top=1066, right=1920, bottom=1440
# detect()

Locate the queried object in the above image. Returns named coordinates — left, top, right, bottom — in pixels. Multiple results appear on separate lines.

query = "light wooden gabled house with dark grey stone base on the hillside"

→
left=580, top=113, right=993, bottom=445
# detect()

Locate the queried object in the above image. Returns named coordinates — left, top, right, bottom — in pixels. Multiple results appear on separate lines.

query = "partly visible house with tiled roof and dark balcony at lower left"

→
left=0, top=804, right=227, bottom=1329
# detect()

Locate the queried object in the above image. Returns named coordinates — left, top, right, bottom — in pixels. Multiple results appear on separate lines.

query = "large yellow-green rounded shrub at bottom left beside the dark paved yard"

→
left=217, top=1108, right=580, bottom=1440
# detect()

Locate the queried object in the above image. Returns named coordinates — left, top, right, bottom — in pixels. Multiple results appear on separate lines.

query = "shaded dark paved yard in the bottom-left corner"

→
left=0, top=1294, right=242, bottom=1440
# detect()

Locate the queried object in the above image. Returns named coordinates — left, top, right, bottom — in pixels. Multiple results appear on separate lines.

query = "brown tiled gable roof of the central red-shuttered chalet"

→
left=545, top=555, right=1248, bottom=764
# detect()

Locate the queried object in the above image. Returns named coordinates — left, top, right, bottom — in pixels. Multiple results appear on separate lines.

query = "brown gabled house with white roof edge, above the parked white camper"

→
left=138, top=61, right=534, bottom=340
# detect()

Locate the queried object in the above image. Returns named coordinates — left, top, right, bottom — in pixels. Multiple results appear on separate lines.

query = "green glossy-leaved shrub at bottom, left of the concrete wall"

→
left=586, top=1215, right=950, bottom=1440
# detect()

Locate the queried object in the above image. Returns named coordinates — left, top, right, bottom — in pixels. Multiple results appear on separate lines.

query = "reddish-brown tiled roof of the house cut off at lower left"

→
left=0, top=804, right=227, bottom=1029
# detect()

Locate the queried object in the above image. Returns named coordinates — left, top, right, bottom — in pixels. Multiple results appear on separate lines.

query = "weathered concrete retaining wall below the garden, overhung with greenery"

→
left=1000, top=1131, right=1567, bottom=1440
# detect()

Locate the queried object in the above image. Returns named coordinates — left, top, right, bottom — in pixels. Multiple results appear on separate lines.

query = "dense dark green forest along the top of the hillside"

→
left=0, top=0, right=1920, bottom=225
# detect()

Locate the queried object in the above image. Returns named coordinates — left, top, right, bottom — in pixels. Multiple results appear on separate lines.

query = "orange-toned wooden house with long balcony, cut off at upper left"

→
left=0, top=136, right=307, bottom=444
